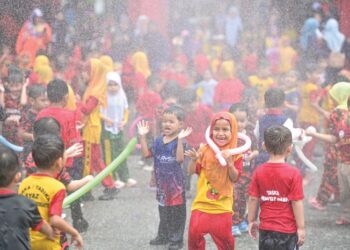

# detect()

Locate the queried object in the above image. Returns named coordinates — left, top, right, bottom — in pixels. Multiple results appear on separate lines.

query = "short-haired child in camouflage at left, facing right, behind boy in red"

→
left=18, top=84, right=48, bottom=160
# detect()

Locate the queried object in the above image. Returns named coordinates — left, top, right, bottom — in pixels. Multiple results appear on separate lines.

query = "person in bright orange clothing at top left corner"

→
left=16, top=9, right=52, bottom=62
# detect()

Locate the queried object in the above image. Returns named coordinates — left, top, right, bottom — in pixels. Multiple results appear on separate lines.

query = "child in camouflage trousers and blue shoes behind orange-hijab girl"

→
left=229, top=103, right=259, bottom=236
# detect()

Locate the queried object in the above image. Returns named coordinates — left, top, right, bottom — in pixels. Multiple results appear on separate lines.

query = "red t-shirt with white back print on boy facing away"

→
left=249, top=162, right=304, bottom=233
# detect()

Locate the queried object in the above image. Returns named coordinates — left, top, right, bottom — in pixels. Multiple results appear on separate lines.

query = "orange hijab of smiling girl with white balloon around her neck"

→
left=200, top=112, right=240, bottom=196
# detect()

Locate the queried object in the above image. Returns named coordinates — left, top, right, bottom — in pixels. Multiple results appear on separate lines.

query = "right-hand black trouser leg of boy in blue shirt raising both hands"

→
left=167, top=203, right=186, bottom=244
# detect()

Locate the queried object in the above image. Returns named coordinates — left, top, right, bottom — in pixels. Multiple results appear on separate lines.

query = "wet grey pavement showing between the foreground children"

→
left=64, top=152, right=350, bottom=250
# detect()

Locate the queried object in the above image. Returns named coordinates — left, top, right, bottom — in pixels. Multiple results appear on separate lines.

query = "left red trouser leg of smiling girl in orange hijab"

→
left=188, top=210, right=210, bottom=250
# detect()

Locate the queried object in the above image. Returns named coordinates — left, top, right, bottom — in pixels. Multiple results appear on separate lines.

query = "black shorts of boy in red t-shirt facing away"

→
left=259, top=230, right=299, bottom=250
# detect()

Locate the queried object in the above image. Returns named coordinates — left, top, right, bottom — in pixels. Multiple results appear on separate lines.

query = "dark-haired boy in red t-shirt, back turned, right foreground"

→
left=248, top=125, right=305, bottom=250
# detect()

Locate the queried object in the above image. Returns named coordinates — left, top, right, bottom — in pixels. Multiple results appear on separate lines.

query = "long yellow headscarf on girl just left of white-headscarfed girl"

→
left=83, top=58, right=107, bottom=107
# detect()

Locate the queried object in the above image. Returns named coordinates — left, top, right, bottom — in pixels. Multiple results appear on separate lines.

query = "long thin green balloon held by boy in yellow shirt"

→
left=63, top=137, right=137, bottom=208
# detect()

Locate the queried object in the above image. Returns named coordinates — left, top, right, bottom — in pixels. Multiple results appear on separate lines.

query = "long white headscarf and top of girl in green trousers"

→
left=101, top=72, right=128, bottom=134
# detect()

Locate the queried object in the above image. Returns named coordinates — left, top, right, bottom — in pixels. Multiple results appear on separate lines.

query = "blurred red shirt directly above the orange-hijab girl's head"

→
left=214, top=79, right=244, bottom=104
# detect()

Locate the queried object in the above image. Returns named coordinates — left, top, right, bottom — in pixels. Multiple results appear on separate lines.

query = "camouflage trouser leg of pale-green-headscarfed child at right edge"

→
left=337, top=163, right=350, bottom=224
